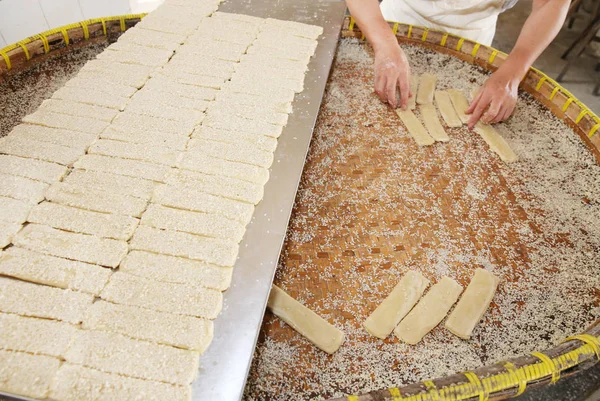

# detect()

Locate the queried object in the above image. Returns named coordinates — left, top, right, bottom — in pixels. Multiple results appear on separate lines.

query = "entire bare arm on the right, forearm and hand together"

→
left=466, top=0, right=570, bottom=128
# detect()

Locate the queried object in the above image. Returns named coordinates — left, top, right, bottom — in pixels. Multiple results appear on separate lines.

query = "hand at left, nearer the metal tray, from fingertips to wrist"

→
left=375, top=37, right=412, bottom=110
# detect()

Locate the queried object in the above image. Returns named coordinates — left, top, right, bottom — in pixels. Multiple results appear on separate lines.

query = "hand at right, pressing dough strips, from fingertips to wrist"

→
left=466, top=69, right=520, bottom=128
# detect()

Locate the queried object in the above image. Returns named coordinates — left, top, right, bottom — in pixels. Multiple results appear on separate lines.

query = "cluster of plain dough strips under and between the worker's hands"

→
left=396, top=73, right=517, bottom=163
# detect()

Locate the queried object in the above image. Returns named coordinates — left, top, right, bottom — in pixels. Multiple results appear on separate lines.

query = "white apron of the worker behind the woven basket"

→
left=381, top=0, right=516, bottom=46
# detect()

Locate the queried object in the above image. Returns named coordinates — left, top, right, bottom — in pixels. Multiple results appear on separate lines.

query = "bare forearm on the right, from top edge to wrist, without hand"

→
left=500, top=0, right=569, bottom=81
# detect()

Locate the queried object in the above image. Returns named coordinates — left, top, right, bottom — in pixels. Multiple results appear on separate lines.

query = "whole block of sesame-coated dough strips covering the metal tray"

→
left=0, top=0, right=322, bottom=401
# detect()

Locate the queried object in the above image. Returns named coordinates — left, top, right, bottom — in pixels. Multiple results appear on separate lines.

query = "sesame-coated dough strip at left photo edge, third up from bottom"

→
left=0, top=277, right=94, bottom=324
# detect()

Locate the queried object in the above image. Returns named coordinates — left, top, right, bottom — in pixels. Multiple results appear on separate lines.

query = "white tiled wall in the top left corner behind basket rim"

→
left=0, top=0, right=164, bottom=48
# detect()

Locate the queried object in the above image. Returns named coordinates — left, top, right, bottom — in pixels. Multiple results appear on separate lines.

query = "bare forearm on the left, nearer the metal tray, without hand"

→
left=346, top=0, right=397, bottom=51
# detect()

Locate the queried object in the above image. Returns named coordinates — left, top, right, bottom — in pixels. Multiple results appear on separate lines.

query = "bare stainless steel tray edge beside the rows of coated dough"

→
left=192, top=0, right=345, bottom=401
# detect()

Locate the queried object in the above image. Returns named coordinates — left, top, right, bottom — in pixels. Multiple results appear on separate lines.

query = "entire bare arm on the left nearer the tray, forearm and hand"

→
left=346, top=0, right=410, bottom=108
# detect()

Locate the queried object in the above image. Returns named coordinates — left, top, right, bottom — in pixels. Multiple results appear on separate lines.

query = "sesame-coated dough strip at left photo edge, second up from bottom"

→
left=0, top=313, right=77, bottom=357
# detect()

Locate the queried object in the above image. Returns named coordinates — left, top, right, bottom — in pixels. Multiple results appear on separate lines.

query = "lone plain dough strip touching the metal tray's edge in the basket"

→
left=267, top=285, right=344, bottom=354
